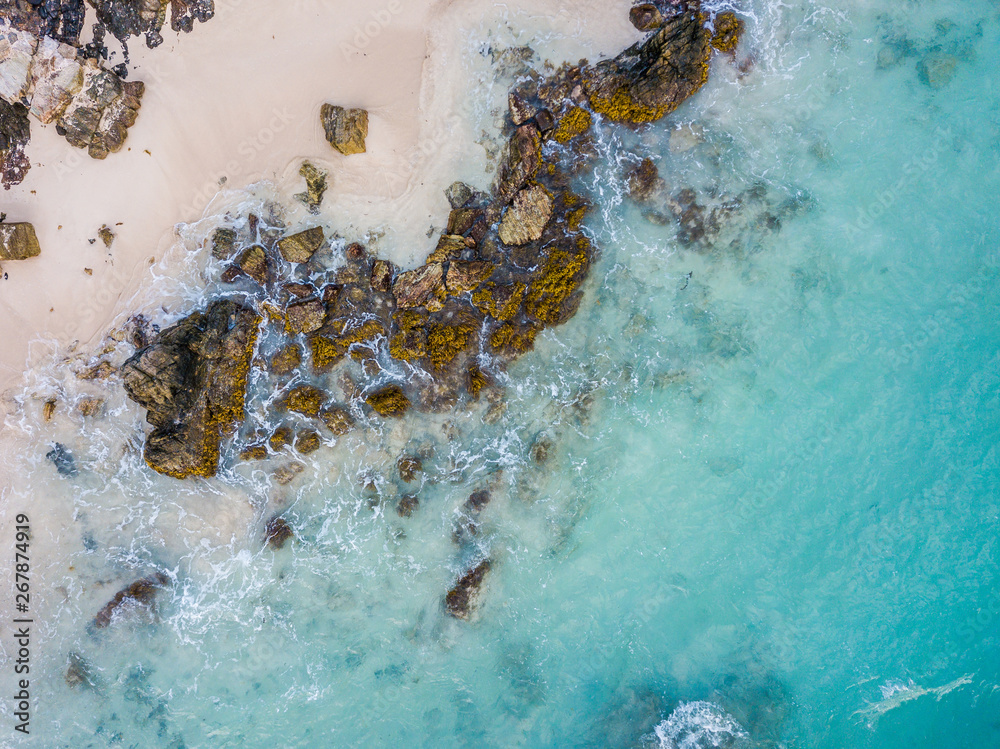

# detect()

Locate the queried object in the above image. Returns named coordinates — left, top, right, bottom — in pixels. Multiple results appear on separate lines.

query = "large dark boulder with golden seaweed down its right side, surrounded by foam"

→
left=122, top=299, right=261, bottom=479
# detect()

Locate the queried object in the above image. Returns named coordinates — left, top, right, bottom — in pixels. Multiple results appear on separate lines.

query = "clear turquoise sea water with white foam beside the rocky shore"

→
left=2, top=0, right=1000, bottom=747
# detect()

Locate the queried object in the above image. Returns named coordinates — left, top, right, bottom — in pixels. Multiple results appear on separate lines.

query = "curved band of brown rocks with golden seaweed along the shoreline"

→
left=117, top=5, right=740, bottom=496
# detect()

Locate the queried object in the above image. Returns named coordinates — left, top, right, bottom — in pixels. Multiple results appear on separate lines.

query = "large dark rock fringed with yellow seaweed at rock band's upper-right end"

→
left=583, top=10, right=712, bottom=124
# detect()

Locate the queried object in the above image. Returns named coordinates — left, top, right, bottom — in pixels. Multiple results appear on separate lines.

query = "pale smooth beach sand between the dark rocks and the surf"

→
left=0, top=0, right=638, bottom=420
